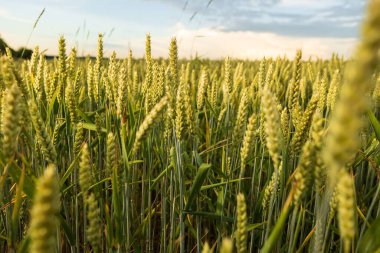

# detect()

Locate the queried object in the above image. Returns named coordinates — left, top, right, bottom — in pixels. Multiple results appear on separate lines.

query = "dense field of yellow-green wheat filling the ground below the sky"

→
left=0, top=0, right=380, bottom=253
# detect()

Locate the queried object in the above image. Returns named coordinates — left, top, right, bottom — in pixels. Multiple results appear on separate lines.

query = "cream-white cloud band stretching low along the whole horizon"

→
left=2, top=20, right=357, bottom=59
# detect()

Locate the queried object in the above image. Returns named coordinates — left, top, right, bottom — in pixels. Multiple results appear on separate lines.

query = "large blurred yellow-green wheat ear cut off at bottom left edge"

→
left=29, top=164, right=60, bottom=253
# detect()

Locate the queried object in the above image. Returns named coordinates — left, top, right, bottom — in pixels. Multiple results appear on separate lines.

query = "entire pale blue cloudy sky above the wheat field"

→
left=0, top=0, right=366, bottom=59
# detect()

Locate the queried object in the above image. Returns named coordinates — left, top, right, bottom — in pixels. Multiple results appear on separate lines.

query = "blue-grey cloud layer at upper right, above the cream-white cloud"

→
left=160, top=0, right=365, bottom=38
